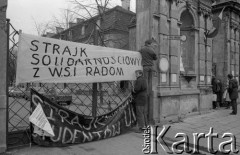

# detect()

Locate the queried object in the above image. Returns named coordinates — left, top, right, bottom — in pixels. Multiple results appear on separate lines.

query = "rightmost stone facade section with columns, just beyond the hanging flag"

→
left=212, top=0, right=240, bottom=85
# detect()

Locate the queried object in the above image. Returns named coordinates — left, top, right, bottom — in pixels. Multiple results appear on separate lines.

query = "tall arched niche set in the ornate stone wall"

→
left=180, top=10, right=195, bottom=74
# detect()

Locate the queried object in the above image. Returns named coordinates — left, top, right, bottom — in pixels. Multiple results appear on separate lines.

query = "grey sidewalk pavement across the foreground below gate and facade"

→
left=5, top=105, right=240, bottom=155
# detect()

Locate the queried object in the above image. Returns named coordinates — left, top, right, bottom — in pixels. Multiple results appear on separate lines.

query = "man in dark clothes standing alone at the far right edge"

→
left=228, top=74, right=238, bottom=115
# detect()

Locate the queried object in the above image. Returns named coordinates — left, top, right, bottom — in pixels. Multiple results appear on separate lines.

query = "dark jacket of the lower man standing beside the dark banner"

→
left=133, top=76, right=147, bottom=106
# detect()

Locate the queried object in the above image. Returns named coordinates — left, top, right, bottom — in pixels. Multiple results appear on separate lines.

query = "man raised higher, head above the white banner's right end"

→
left=139, top=39, right=157, bottom=82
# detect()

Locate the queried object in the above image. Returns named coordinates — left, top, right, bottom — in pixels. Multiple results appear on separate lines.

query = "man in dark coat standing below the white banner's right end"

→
left=133, top=70, right=148, bottom=132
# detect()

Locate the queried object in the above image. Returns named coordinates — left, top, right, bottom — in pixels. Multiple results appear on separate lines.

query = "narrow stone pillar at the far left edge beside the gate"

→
left=0, top=0, right=7, bottom=153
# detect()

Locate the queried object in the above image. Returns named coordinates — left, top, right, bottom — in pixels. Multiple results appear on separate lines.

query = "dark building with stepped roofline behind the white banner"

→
left=51, top=5, right=135, bottom=49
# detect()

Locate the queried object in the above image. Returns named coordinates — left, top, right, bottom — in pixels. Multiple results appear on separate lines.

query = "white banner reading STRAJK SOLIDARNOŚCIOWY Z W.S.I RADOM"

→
left=16, top=34, right=142, bottom=84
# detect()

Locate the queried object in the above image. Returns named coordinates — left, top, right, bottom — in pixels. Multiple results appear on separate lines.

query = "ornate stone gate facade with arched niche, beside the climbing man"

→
left=132, top=0, right=215, bottom=123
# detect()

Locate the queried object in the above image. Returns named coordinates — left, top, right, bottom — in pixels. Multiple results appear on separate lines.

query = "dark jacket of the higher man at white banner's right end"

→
left=139, top=45, right=157, bottom=66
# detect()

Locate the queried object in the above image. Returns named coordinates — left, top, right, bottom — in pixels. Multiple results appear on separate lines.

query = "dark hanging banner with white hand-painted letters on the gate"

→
left=31, top=89, right=136, bottom=146
